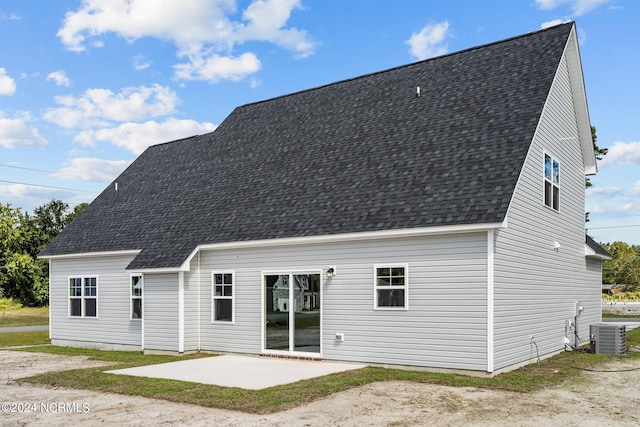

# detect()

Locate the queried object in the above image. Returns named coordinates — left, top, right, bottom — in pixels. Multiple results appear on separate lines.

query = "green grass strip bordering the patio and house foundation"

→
left=11, top=338, right=640, bottom=414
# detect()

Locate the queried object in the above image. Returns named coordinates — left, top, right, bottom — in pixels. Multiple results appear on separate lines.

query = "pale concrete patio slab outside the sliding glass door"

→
left=107, top=355, right=367, bottom=390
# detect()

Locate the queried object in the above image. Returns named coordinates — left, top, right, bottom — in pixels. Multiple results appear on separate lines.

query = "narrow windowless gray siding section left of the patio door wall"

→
left=144, top=273, right=180, bottom=351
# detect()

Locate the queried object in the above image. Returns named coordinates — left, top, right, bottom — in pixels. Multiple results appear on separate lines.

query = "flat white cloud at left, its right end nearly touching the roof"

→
left=75, top=118, right=216, bottom=155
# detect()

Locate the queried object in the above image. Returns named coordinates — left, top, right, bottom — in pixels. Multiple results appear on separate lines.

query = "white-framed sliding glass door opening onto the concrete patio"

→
left=263, top=273, right=321, bottom=353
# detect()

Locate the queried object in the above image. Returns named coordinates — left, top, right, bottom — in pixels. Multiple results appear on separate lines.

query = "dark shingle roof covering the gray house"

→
left=41, top=24, right=573, bottom=269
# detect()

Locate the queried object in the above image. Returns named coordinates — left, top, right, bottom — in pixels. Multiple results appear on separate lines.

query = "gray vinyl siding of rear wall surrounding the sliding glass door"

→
left=185, top=232, right=487, bottom=371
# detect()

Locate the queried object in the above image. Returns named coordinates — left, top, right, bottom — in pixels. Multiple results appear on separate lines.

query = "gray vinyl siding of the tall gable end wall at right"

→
left=494, top=51, right=601, bottom=369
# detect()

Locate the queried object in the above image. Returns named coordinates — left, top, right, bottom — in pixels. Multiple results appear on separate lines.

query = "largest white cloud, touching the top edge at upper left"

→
left=58, top=0, right=316, bottom=82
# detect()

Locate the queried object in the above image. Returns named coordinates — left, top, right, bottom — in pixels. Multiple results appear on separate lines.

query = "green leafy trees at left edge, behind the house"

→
left=0, top=200, right=88, bottom=307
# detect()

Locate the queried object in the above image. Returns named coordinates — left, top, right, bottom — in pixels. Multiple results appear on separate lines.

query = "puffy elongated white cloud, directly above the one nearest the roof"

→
left=44, top=85, right=179, bottom=128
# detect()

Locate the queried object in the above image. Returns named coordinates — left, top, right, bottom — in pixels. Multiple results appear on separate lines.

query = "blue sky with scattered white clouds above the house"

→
left=0, top=0, right=640, bottom=244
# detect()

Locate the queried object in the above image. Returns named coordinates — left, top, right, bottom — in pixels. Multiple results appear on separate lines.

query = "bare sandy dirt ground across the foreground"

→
left=0, top=351, right=640, bottom=427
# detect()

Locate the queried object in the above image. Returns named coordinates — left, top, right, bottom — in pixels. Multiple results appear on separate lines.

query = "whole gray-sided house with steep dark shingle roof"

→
left=41, top=23, right=603, bottom=373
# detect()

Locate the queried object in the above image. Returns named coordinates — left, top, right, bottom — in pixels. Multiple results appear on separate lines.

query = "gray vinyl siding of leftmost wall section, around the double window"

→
left=49, top=255, right=142, bottom=346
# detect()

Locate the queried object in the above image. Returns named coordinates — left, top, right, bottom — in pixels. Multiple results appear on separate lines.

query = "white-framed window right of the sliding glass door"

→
left=373, top=264, right=409, bottom=310
